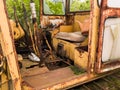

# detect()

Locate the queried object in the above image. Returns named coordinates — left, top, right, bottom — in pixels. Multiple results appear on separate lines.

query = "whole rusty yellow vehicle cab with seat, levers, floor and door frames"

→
left=0, top=0, right=120, bottom=90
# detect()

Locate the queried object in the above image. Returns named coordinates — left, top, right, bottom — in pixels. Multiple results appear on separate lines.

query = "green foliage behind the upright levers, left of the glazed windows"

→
left=6, top=0, right=39, bottom=24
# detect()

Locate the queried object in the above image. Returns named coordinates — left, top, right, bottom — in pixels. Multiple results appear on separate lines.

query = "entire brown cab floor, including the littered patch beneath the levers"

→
left=21, top=59, right=75, bottom=90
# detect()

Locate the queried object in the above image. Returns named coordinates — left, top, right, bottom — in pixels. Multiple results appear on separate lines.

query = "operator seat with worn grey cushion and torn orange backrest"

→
left=55, top=19, right=90, bottom=43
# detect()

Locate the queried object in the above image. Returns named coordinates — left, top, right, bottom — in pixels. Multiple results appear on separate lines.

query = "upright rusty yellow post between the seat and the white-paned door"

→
left=88, top=0, right=100, bottom=73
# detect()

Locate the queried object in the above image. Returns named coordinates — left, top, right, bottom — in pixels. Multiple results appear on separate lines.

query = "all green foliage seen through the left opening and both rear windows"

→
left=6, top=0, right=90, bottom=24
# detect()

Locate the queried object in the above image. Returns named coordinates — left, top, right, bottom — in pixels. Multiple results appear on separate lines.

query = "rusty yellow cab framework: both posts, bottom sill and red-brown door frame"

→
left=0, top=0, right=120, bottom=90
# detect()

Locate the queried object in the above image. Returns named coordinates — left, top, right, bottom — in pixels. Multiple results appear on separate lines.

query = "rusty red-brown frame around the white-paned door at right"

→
left=96, top=0, right=120, bottom=73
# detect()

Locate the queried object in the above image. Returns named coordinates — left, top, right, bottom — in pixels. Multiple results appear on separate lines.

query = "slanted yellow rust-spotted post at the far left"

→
left=0, top=0, right=21, bottom=90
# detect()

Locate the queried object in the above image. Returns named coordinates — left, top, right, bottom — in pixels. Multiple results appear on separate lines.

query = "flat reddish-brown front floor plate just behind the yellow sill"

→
left=23, top=67, right=75, bottom=90
